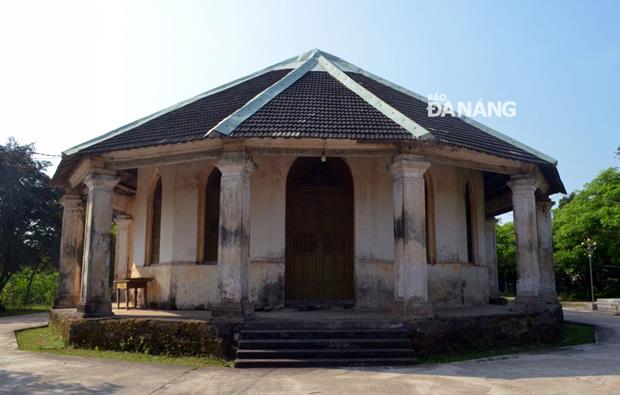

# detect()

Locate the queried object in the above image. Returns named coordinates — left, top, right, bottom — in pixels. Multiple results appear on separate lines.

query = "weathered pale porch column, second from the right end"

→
left=508, top=176, right=540, bottom=310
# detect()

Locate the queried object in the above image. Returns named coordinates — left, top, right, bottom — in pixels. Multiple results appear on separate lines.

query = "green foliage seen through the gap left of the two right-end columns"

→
left=495, top=222, right=517, bottom=294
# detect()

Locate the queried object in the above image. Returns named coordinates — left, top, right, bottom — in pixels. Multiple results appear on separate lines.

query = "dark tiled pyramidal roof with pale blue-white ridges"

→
left=63, top=50, right=554, bottom=169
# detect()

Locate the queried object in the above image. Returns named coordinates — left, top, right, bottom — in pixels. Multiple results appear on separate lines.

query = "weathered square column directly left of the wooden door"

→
left=209, top=152, right=256, bottom=318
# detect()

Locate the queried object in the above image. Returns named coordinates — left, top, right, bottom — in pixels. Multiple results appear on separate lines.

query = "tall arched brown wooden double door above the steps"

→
left=285, top=158, right=354, bottom=304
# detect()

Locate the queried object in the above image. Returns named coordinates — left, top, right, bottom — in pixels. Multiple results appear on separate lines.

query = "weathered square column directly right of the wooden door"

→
left=390, top=155, right=433, bottom=318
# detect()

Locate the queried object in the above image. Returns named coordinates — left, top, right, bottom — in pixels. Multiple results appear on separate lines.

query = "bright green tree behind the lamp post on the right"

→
left=553, top=168, right=620, bottom=297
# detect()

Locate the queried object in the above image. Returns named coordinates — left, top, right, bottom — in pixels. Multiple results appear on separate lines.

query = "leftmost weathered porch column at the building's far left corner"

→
left=54, top=193, right=84, bottom=309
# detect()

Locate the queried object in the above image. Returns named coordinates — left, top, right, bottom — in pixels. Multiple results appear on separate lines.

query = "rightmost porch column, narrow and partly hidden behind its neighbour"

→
left=536, top=200, right=558, bottom=304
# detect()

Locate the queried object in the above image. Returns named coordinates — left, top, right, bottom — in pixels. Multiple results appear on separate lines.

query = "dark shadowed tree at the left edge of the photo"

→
left=0, top=138, right=61, bottom=310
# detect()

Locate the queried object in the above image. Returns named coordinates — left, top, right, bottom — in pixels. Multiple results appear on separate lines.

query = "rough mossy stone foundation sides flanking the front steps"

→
left=49, top=309, right=563, bottom=359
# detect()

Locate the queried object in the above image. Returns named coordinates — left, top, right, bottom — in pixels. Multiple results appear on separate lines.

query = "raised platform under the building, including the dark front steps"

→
left=50, top=304, right=562, bottom=367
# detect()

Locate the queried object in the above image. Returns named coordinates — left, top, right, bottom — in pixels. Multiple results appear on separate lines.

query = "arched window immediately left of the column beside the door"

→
left=198, top=168, right=222, bottom=262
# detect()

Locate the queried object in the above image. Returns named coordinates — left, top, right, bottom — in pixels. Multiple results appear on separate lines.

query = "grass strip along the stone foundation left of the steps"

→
left=16, top=326, right=232, bottom=368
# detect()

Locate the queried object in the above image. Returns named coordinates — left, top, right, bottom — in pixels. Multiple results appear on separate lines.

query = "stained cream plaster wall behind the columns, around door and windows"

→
left=127, top=156, right=488, bottom=308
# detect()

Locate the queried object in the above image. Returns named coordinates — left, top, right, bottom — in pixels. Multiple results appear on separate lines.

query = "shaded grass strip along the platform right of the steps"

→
left=418, top=322, right=595, bottom=363
